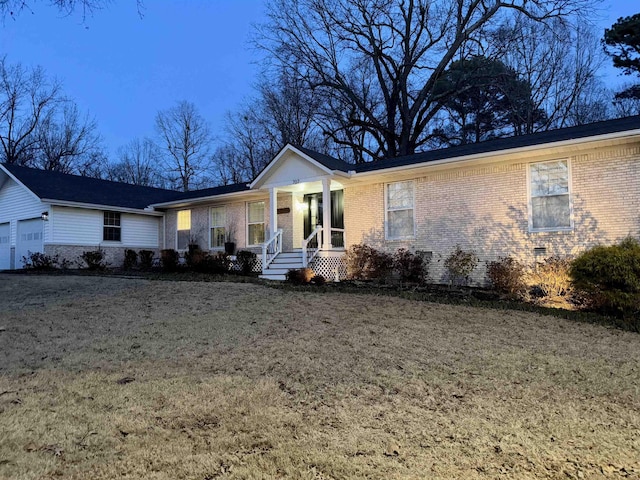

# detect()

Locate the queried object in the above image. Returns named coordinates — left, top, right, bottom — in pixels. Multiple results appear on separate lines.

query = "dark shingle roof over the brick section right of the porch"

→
left=349, top=115, right=640, bottom=173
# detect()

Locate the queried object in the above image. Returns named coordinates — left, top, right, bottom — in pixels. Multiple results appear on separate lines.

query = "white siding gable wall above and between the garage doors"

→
left=0, top=179, right=49, bottom=246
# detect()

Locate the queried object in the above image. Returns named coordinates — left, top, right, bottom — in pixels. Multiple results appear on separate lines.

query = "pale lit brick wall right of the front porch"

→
left=344, top=146, right=640, bottom=284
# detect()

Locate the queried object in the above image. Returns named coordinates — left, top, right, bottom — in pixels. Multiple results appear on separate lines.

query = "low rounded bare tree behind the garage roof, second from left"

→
left=34, top=100, right=101, bottom=173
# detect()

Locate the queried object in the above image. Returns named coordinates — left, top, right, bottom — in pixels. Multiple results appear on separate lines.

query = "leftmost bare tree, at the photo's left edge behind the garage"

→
left=0, top=58, right=61, bottom=165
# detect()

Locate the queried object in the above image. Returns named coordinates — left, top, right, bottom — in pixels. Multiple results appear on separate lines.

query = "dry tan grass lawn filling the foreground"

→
left=0, top=275, right=640, bottom=480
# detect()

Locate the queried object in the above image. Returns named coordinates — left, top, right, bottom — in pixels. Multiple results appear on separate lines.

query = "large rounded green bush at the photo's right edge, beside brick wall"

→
left=570, top=237, right=640, bottom=322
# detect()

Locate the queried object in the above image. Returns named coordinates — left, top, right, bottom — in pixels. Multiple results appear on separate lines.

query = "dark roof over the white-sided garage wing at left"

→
left=2, top=164, right=184, bottom=210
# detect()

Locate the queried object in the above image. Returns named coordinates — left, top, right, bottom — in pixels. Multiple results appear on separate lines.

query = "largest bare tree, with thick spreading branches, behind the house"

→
left=258, top=0, right=591, bottom=161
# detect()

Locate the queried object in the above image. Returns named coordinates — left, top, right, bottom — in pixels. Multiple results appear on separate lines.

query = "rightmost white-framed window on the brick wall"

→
left=529, top=160, right=571, bottom=230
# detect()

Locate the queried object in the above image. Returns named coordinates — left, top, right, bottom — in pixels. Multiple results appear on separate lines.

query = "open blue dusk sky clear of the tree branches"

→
left=0, top=0, right=640, bottom=158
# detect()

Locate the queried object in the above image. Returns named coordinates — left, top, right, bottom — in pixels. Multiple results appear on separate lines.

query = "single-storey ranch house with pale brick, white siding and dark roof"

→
left=0, top=116, right=640, bottom=282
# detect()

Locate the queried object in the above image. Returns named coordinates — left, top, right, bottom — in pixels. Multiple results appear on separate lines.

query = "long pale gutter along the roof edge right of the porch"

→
left=351, top=129, right=640, bottom=178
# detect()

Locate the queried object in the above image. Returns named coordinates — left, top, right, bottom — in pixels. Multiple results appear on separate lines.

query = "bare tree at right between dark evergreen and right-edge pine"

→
left=493, top=14, right=611, bottom=131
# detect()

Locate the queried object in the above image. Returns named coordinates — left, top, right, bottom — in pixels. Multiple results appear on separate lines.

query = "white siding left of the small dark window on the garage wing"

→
left=48, top=207, right=104, bottom=246
